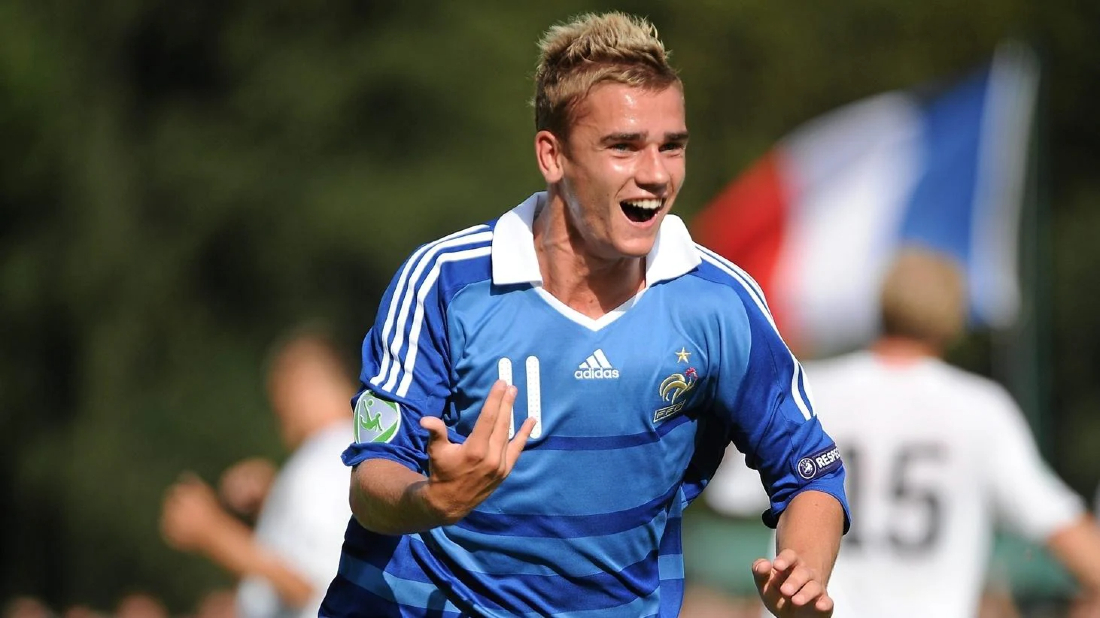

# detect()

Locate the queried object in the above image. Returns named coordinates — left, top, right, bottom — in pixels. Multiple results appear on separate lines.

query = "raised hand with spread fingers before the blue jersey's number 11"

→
left=420, top=380, right=535, bottom=523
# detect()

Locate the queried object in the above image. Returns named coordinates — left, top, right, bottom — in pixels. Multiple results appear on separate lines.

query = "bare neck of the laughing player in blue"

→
left=534, top=192, right=646, bottom=319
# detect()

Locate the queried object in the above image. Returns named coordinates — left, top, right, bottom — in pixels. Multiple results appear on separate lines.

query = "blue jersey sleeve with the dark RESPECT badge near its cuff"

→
left=716, top=285, right=850, bottom=531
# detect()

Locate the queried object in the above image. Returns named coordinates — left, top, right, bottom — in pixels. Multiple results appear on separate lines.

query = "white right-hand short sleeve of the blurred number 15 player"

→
left=982, top=387, right=1085, bottom=542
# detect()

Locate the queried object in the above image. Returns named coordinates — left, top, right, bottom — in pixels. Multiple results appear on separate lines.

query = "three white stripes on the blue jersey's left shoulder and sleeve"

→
left=370, top=224, right=493, bottom=397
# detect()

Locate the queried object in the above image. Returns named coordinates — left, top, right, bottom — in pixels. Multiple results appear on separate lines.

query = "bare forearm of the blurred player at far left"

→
left=194, top=516, right=315, bottom=607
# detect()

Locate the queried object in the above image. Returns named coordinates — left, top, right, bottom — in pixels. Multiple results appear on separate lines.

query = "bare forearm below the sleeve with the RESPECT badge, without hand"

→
left=776, top=490, right=844, bottom=583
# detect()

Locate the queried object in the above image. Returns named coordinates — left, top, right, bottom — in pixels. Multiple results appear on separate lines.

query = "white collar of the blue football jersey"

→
left=492, top=191, right=702, bottom=287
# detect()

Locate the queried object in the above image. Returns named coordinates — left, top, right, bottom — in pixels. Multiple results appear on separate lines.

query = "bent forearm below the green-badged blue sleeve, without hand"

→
left=351, top=459, right=455, bottom=536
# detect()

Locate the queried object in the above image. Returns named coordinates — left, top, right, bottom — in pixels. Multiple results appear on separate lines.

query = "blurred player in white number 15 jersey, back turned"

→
left=704, top=249, right=1100, bottom=618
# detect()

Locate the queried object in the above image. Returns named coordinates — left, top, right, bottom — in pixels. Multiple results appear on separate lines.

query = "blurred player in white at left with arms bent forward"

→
left=161, top=333, right=354, bottom=618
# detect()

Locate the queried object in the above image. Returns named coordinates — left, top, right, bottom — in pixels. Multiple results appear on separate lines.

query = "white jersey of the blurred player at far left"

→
left=237, top=422, right=352, bottom=618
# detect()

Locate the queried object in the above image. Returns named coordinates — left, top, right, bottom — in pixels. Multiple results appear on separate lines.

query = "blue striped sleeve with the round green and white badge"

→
left=342, top=245, right=450, bottom=472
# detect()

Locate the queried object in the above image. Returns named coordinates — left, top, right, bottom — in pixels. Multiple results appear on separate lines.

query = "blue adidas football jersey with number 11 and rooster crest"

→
left=321, top=194, right=847, bottom=618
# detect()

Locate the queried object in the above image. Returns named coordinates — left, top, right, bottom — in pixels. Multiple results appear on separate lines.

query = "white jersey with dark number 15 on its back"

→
left=704, top=352, right=1085, bottom=618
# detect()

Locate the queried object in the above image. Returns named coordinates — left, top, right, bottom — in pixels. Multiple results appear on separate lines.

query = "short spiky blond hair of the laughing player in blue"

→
left=532, top=12, right=680, bottom=140
